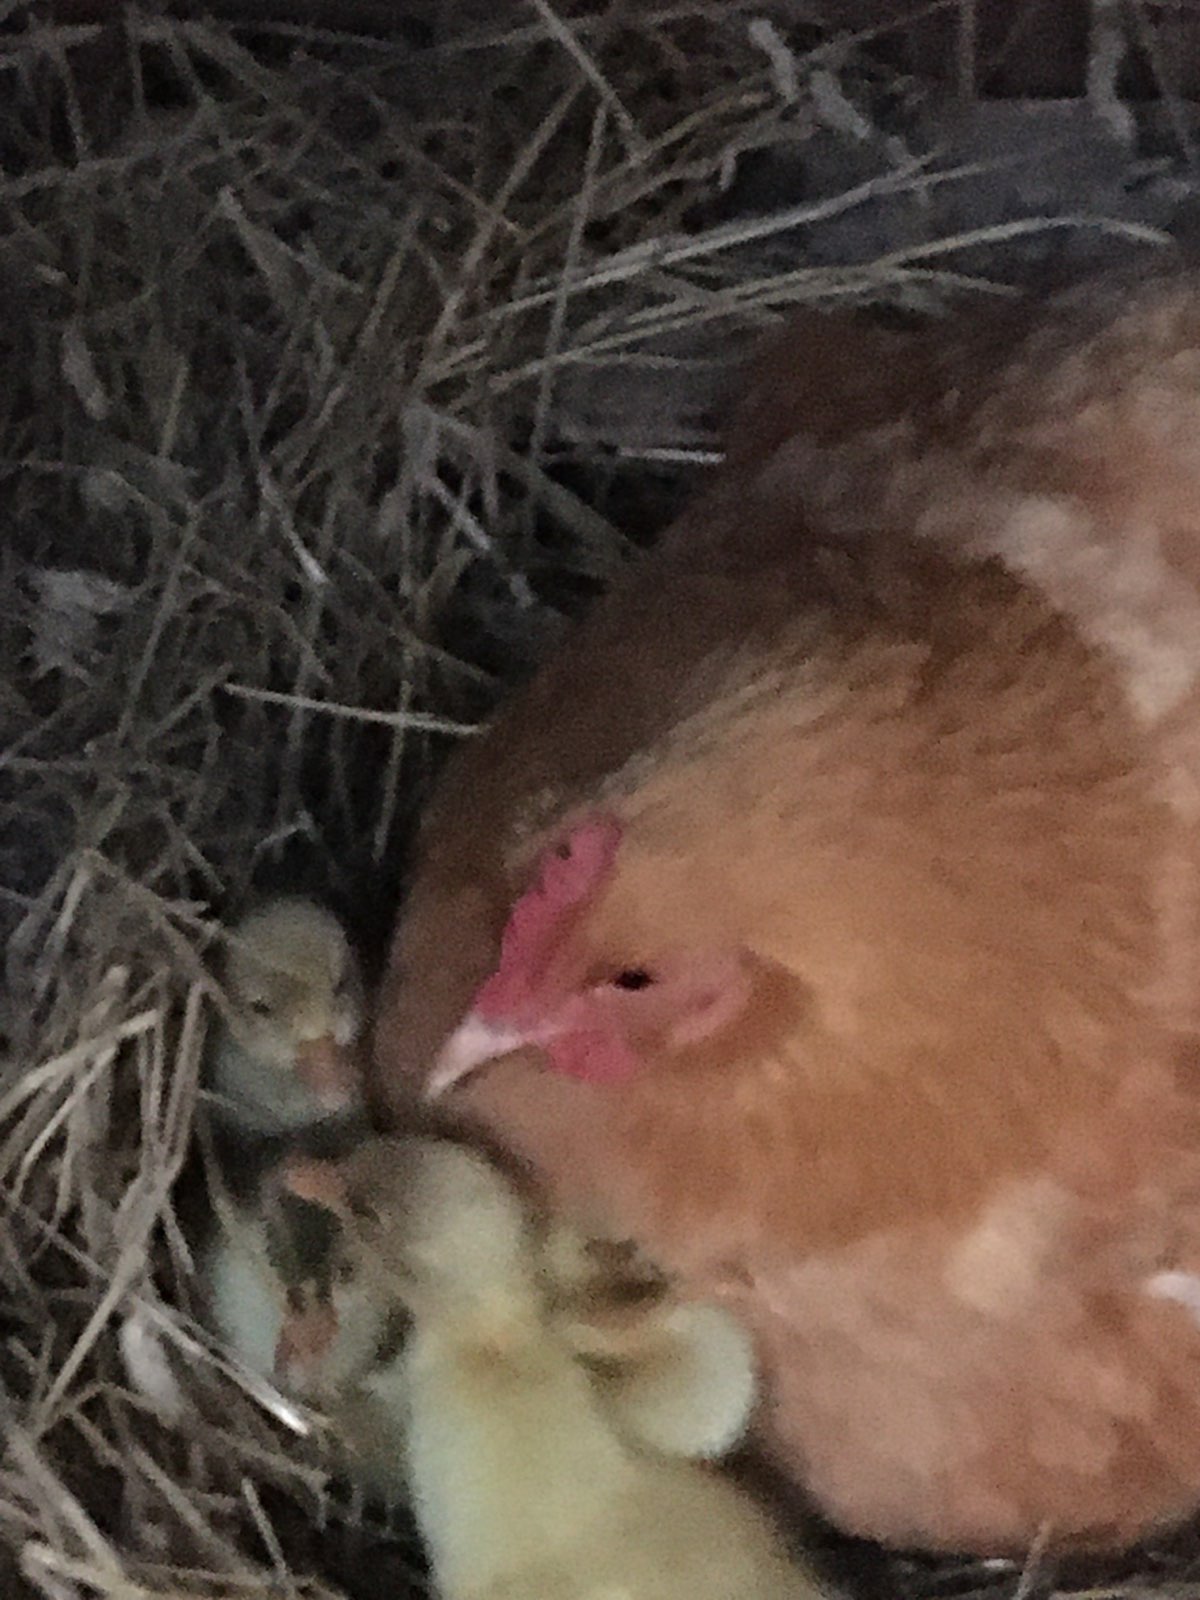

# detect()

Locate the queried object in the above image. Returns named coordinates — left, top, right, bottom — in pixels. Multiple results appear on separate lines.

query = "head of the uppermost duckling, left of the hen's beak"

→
left=211, top=898, right=365, bottom=1133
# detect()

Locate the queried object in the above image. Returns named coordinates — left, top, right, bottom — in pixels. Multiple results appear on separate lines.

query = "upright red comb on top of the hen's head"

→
left=474, top=818, right=621, bottom=1021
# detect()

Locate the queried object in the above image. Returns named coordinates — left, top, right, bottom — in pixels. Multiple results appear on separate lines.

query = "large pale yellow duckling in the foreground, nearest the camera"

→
left=280, top=1138, right=822, bottom=1600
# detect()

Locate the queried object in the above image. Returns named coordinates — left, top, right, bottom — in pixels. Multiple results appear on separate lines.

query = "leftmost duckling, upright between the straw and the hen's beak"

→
left=200, top=896, right=365, bottom=1378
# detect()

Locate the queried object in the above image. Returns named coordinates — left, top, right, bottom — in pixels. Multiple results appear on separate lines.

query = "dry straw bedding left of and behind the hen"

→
left=0, top=0, right=1200, bottom=1600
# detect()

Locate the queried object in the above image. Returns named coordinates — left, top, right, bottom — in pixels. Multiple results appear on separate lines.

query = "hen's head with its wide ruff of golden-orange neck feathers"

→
left=376, top=555, right=1168, bottom=1270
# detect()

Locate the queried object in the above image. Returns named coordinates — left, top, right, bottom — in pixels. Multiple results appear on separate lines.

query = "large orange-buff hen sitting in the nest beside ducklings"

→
left=376, top=275, right=1200, bottom=1554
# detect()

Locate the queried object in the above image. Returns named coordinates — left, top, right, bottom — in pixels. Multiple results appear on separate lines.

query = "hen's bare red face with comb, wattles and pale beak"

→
left=427, top=816, right=752, bottom=1094
